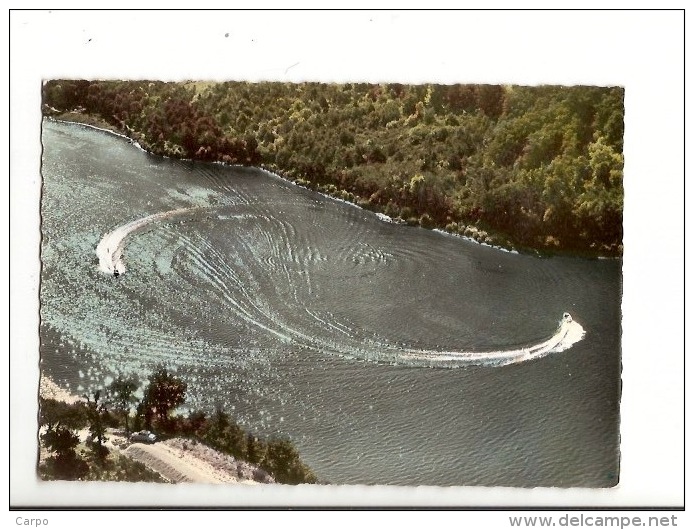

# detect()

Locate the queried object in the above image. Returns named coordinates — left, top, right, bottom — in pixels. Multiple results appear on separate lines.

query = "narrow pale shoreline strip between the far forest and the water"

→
left=42, top=111, right=623, bottom=260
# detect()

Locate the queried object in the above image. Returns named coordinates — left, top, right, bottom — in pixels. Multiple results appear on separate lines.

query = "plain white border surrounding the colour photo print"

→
left=4, top=6, right=691, bottom=507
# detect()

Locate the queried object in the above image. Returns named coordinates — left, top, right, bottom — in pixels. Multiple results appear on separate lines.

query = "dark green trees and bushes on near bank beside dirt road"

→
left=39, top=367, right=317, bottom=484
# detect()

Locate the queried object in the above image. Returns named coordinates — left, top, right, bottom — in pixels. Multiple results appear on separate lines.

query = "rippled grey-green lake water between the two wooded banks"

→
left=40, top=121, right=622, bottom=487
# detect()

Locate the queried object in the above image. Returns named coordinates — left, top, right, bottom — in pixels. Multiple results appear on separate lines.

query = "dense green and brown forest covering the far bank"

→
left=42, top=80, right=624, bottom=256
